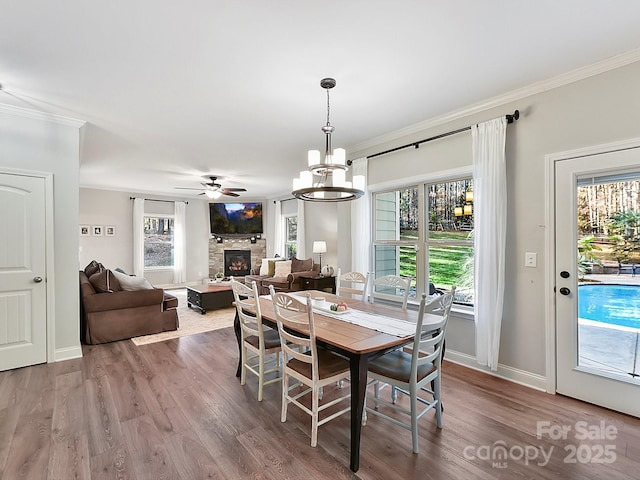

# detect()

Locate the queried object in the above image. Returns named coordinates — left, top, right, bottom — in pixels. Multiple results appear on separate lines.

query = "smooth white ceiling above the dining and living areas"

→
left=0, top=0, right=640, bottom=199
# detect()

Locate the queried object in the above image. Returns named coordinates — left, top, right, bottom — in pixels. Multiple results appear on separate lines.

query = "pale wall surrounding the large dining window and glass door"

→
left=348, top=58, right=640, bottom=387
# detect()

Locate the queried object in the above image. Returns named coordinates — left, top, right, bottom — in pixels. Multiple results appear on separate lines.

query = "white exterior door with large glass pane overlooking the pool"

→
left=554, top=148, right=640, bottom=416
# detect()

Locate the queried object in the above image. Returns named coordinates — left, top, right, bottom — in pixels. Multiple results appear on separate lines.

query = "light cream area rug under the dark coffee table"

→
left=131, top=289, right=236, bottom=345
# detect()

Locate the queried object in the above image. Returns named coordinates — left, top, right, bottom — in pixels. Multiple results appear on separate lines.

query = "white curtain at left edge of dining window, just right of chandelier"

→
left=351, top=157, right=371, bottom=275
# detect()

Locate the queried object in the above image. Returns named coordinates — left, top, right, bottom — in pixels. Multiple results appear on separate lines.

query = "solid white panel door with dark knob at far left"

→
left=0, top=173, right=47, bottom=370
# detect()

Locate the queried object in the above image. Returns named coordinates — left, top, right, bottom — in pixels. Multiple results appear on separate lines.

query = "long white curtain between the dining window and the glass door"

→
left=471, top=117, right=507, bottom=371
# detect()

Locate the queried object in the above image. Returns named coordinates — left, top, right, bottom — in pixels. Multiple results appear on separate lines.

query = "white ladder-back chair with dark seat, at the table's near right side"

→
left=363, top=287, right=455, bottom=453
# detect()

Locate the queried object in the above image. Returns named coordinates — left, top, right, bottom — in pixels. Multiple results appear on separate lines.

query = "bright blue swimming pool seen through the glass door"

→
left=578, top=284, right=640, bottom=329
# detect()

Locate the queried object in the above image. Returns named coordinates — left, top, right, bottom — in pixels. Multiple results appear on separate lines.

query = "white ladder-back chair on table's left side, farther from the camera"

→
left=231, top=278, right=281, bottom=402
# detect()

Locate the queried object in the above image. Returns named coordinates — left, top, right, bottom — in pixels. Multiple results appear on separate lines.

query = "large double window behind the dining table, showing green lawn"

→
left=373, top=178, right=473, bottom=305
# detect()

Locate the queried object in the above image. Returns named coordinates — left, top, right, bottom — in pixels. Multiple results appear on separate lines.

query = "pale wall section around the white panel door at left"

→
left=0, top=105, right=82, bottom=360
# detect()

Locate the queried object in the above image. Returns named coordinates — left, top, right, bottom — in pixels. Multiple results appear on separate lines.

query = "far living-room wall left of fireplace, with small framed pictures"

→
left=77, top=188, right=209, bottom=286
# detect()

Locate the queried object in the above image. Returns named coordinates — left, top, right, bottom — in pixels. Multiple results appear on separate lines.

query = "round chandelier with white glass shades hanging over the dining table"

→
left=291, top=78, right=364, bottom=202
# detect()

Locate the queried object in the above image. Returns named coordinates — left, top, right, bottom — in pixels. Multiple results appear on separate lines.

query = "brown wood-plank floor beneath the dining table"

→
left=0, top=328, right=640, bottom=480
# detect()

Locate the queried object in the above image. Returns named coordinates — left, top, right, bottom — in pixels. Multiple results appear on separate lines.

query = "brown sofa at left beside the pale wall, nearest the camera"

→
left=79, top=262, right=179, bottom=344
